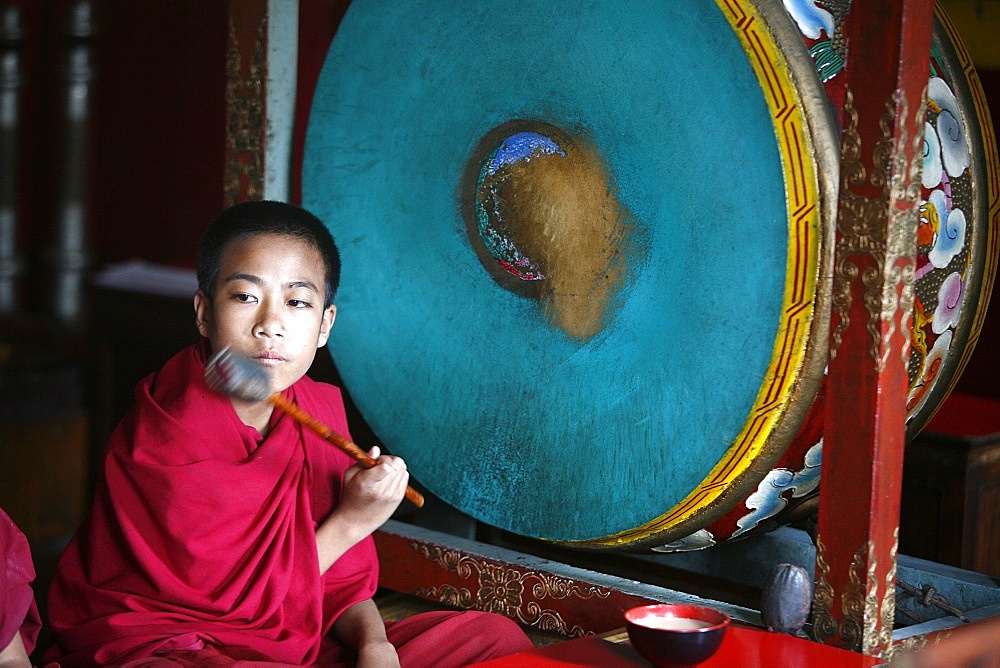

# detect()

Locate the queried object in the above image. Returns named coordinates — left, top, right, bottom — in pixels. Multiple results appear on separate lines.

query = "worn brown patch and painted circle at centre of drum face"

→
left=467, top=121, right=637, bottom=342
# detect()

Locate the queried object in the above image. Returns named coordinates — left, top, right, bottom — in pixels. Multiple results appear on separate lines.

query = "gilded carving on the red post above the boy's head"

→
left=224, top=10, right=267, bottom=205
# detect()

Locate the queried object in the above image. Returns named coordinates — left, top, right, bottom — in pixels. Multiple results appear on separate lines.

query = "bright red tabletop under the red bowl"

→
left=475, top=625, right=881, bottom=668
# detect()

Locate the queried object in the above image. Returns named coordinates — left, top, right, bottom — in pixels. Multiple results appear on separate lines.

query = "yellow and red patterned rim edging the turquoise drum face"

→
left=559, top=0, right=839, bottom=549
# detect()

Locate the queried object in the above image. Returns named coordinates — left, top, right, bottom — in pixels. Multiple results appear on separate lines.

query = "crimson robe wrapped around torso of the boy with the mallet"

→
left=46, top=345, right=524, bottom=666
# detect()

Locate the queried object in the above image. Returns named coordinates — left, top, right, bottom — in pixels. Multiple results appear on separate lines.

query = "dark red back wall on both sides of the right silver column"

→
left=13, top=0, right=228, bottom=276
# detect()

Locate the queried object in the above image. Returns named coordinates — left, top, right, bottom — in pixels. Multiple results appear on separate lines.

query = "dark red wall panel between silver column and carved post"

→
left=91, top=0, right=228, bottom=266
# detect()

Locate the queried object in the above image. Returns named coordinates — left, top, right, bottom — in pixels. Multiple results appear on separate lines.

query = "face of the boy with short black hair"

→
left=195, top=233, right=337, bottom=392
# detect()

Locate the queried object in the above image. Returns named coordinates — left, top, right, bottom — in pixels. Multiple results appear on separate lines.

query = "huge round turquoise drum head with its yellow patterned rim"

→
left=303, top=0, right=1000, bottom=549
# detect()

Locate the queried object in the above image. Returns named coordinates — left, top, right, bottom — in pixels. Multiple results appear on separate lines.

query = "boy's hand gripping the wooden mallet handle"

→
left=341, top=446, right=410, bottom=531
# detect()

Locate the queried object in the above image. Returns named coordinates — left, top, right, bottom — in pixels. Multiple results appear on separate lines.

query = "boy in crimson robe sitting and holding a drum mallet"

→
left=46, top=202, right=531, bottom=668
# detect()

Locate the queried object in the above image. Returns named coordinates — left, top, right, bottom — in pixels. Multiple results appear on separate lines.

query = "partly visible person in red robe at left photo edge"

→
left=0, top=509, right=42, bottom=668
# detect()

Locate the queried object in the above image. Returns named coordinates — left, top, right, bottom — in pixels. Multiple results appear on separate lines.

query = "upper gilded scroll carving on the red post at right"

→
left=830, top=87, right=924, bottom=372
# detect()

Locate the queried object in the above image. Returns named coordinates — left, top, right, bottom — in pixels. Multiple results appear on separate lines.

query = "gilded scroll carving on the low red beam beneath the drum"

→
left=409, top=541, right=611, bottom=637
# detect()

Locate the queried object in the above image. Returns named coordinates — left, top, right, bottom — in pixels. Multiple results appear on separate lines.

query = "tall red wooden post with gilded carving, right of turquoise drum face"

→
left=813, top=0, right=934, bottom=656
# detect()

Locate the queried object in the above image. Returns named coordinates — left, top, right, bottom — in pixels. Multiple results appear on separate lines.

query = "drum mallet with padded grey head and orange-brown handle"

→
left=205, top=346, right=424, bottom=508
